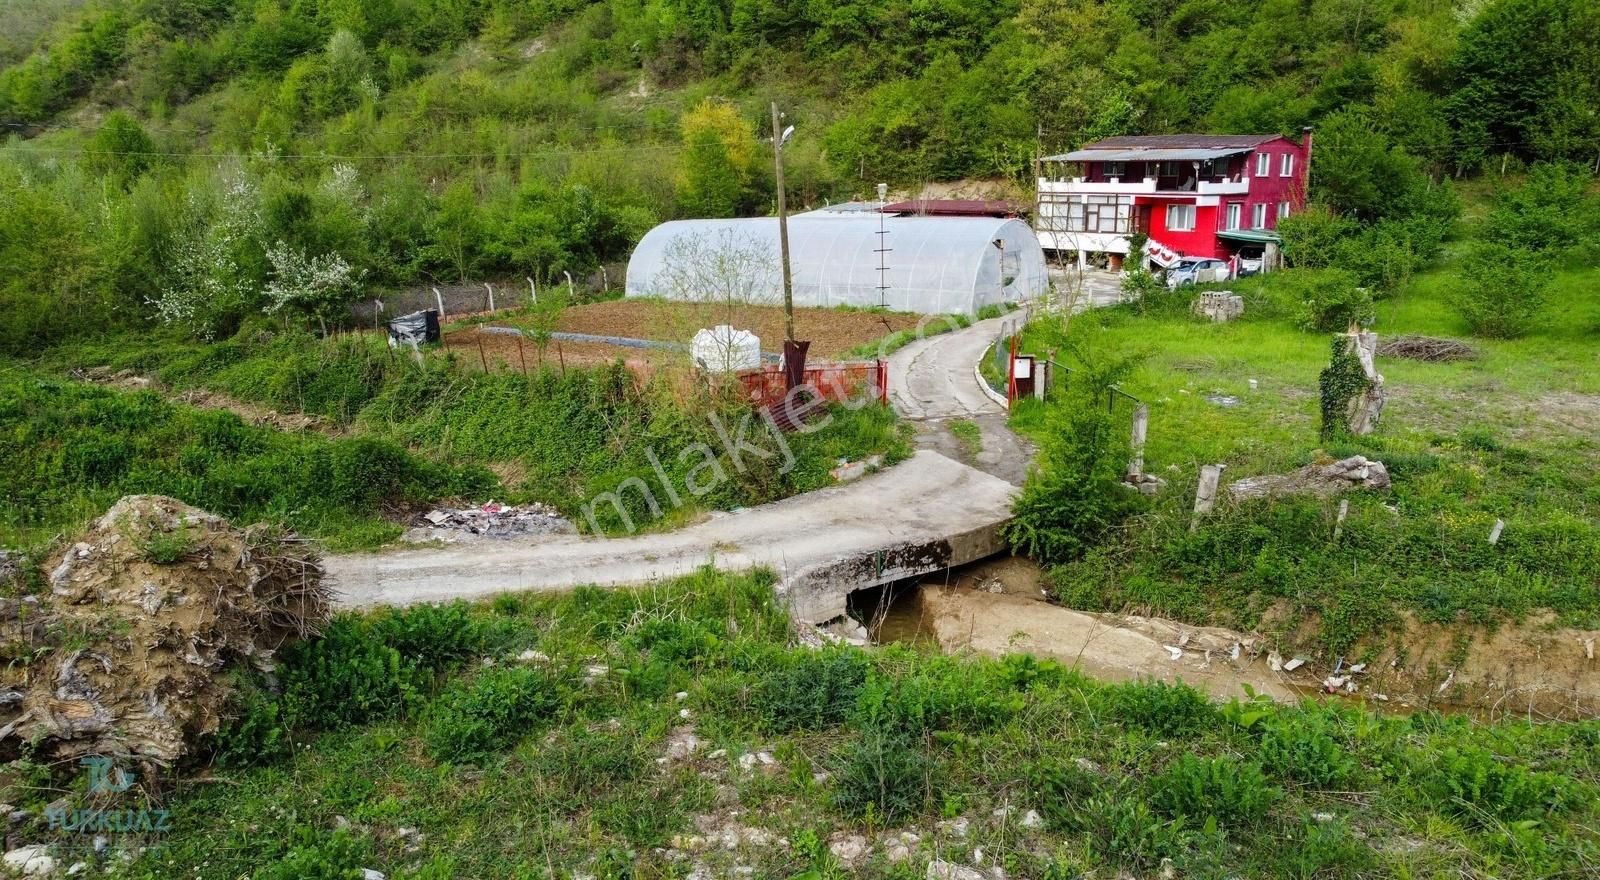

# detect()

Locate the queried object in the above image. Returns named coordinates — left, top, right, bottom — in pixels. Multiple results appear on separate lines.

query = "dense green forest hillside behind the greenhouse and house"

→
left=0, top=0, right=1600, bottom=354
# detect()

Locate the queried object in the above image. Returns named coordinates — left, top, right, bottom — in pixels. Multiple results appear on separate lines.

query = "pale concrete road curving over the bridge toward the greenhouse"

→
left=325, top=322, right=1016, bottom=606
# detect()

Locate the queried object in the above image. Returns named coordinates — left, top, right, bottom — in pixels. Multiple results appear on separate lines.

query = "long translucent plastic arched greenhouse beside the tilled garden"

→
left=627, top=211, right=1050, bottom=315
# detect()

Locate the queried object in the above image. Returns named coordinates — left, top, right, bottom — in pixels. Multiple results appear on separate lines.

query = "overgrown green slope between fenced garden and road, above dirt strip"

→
left=18, top=326, right=910, bottom=546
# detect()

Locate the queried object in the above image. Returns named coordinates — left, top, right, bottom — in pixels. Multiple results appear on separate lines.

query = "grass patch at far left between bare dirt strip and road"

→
left=0, top=371, right=494, bottom=550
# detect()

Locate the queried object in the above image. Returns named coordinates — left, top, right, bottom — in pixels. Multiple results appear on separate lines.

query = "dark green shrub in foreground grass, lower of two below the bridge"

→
left=834, top=725, right=938, bottom=822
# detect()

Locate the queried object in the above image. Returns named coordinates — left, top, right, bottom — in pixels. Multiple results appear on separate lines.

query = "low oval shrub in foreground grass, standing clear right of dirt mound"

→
left=422, top=666, right=562, bottom=763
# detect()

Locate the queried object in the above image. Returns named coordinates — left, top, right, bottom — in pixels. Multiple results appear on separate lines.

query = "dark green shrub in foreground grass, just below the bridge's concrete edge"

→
left=750, top=648, right=867, bottom=733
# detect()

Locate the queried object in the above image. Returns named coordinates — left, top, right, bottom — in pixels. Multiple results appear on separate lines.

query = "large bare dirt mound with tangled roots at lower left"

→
left=0, top=496, right=331, bottom=765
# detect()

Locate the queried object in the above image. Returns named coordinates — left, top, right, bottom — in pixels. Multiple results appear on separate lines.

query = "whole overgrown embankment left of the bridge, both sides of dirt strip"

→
left=3, top=326, right=909, bottom=546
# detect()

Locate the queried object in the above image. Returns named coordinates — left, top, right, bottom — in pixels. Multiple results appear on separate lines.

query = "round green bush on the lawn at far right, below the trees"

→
left=1451, top=242, right=1550, bottom=339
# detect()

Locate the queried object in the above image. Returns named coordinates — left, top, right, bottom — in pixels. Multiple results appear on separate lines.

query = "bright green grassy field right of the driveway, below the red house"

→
left=1013, top=261, right=1600, bottom=653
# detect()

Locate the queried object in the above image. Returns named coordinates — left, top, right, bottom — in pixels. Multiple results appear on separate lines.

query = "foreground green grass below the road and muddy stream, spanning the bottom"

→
left=21, top=571, right=1600, bottom=880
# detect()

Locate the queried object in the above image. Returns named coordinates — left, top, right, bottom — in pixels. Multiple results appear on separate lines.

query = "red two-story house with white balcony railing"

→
left=1034, top=128, right=1310, bottom=269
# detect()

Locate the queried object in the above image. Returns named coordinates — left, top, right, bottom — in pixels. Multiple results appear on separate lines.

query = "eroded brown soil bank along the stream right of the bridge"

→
left=870, top=558, right=1600, bottom=718
